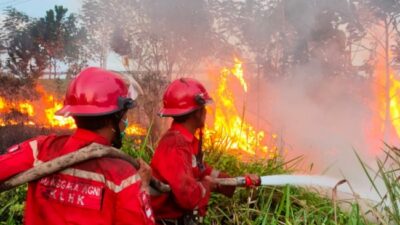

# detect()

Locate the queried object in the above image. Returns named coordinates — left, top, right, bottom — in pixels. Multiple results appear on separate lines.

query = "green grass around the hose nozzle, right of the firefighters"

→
left=202, top=148, right=370, bottom=225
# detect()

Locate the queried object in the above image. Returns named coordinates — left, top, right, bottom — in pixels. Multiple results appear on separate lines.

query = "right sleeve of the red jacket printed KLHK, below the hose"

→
left=114, top=178, right=155, bottom=225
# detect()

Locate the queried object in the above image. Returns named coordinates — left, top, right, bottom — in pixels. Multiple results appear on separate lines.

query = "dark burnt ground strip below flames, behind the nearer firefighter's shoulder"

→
left=0, top=125, right=71, bottom=154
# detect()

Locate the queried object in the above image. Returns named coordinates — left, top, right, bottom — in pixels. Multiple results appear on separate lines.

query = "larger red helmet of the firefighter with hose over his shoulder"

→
left=56, top=67, right=135, bottom=116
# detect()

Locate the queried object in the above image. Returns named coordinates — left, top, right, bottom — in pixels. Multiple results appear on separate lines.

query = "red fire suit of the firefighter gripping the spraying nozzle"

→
left=150, top=123, right=235, bottom=219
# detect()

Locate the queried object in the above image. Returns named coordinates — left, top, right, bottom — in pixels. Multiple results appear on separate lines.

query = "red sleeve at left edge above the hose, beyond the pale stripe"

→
left=0, top=140, right=37, bottom=181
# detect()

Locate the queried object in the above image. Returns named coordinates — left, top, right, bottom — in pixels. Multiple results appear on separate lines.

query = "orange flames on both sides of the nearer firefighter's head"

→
left=0, top=86, right=146, bottom=135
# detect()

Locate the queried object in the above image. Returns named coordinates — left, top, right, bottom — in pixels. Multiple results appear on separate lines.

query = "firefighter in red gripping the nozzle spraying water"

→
left=150, top=78, right=260, bottom=225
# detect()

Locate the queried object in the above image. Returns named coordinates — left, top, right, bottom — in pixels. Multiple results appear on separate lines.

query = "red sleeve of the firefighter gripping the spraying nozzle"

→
left=152, top=147, right=210, bottom=210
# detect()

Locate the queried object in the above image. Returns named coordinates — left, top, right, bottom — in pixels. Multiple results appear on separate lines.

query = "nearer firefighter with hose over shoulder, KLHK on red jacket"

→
left=0, top=67, right=154, bottom=225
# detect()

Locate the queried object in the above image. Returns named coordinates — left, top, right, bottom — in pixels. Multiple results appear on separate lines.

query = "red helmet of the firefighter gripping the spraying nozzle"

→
left=159, top=78, right=212, bottom=117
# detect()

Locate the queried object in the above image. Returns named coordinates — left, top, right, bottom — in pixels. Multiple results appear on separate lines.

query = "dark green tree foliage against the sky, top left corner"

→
left=2, top=6, right=90, bottom=79
